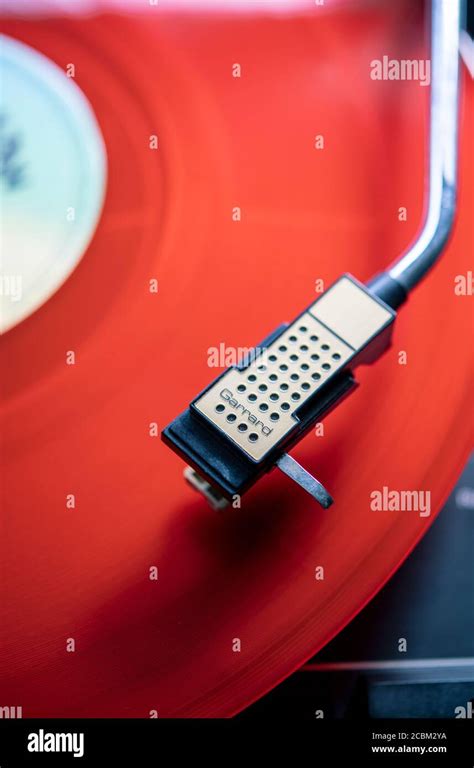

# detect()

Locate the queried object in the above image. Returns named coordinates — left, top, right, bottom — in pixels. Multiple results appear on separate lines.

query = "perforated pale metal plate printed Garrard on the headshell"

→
left=194, top=312, right=354, bottom=461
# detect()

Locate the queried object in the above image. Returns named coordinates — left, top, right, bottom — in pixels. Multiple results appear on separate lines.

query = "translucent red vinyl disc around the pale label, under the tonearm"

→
left=0, top=1, right=474, bottom=717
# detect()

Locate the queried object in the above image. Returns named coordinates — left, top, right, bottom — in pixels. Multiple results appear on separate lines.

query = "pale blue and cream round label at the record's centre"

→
left=0, top=36, right=106, bottom=332
